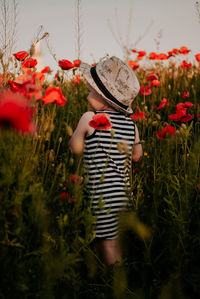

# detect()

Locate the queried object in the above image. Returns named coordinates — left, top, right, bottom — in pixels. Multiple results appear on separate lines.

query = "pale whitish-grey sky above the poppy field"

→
left=16, top=0, right=200, bottom=71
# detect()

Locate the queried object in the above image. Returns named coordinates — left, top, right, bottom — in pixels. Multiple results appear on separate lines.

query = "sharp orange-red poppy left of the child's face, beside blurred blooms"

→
left=42, top=86, right=67, bottom=106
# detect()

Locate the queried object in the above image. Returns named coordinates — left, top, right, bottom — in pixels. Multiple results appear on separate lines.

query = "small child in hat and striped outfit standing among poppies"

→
left=69, top=56, right=143, bottom=265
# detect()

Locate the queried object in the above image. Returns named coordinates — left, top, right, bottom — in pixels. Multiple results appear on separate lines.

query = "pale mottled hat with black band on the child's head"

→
left=80, top=56, right=140, bottom=114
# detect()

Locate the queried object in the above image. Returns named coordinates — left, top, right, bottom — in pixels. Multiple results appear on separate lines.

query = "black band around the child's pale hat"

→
left=90, top=66, right=128, bottom=109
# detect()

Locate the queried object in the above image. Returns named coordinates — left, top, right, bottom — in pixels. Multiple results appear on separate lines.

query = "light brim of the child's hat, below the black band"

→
left=80, top=62, right=133, bottom=114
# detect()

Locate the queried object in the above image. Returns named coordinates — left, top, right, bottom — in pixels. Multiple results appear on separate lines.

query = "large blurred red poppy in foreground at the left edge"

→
left=0, top=90, right=35, bottom=134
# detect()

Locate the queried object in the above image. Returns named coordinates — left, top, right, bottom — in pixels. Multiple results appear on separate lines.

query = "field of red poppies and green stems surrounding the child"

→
left=0, top=47, right=200, bottom=299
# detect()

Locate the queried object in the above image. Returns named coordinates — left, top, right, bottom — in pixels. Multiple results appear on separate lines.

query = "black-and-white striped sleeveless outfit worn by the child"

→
left=84, top=110, right=135, bottom=239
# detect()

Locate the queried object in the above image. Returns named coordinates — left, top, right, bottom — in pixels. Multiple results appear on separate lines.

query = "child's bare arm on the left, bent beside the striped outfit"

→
left=68, top=111, right=94, bottom=155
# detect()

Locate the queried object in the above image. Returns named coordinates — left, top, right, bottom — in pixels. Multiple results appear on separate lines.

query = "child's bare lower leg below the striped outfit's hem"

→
left=100, top=239, right=122, bottom=265
